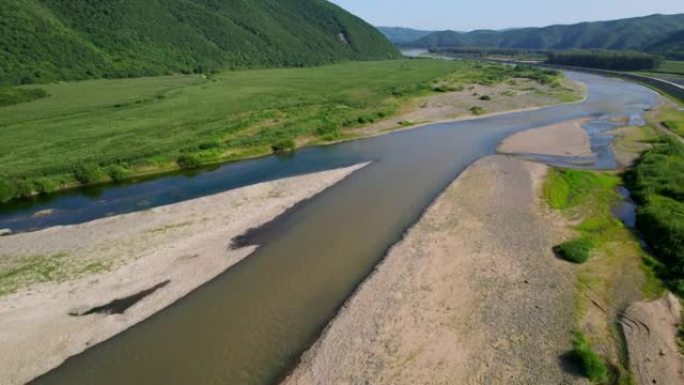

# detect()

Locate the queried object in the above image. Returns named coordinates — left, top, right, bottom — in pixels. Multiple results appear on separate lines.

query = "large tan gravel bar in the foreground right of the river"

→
left=284, top=156, right=584, bottom=385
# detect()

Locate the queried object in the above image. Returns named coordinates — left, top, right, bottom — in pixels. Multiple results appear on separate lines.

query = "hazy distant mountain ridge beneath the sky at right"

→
left=404, top=14, right=684, bottom=54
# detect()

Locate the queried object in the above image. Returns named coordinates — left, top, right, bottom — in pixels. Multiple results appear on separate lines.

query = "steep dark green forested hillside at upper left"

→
left=0, top=0, right=399, bottom=84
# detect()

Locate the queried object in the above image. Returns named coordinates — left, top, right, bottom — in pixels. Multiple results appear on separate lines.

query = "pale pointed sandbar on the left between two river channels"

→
left=0, top=165, right=363, bottom=385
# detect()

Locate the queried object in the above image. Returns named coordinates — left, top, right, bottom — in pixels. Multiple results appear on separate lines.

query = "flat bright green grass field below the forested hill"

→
left=0, top=60, right=568, bottom=201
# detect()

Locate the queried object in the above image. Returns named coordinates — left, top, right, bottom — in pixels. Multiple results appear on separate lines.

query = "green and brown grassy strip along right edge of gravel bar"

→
left=543, top=169, right=648, bottom=384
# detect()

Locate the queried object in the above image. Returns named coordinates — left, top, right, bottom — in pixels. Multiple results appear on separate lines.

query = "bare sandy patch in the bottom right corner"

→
left=620, top=294, right=684, bottom=385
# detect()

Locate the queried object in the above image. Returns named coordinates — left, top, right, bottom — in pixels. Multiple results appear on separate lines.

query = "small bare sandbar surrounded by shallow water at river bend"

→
left=498, top=119, right=592, bottom=157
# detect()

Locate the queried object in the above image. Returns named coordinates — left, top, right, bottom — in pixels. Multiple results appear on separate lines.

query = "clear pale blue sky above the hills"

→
left=331, top=0, right=684, bottom=31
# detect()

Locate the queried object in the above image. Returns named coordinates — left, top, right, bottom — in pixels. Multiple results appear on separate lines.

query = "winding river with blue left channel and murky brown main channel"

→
left=13, top=73, right=656, bottom=385
